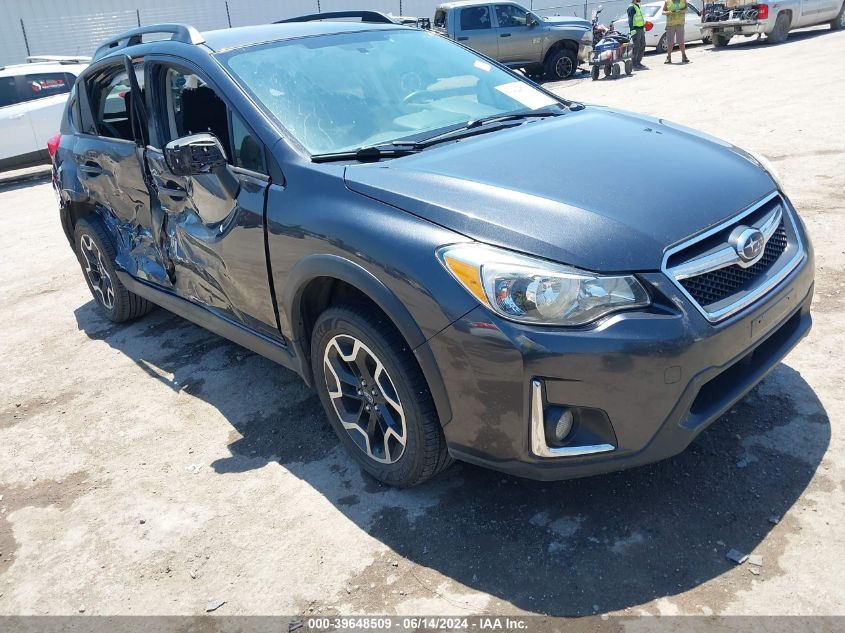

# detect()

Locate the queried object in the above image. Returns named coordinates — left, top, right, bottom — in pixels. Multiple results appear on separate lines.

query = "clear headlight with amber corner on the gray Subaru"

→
left=437, top=244, right=650, bottom=325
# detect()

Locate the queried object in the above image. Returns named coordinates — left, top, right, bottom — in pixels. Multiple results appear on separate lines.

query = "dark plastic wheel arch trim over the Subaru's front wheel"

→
left=281, top=254, right=452, bottom=425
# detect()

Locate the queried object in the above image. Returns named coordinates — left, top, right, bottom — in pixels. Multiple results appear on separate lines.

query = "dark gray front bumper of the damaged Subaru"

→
left=426, top=238, right=813, bottom=480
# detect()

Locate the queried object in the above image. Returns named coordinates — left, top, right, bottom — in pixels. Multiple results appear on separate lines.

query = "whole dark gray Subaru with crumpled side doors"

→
left=53, top=20, right=814, bottom=486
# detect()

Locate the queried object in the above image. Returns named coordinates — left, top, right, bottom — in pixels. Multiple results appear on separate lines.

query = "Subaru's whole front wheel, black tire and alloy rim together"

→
left=311, top=305, right=452, bottom=487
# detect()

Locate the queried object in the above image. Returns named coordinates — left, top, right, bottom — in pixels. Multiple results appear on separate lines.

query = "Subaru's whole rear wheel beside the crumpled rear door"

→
left=73, top=217, right=155, bottom=323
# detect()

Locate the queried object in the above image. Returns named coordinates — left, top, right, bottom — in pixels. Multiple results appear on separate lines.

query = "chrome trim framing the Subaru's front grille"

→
left=660, top=191, right=806, bottom=323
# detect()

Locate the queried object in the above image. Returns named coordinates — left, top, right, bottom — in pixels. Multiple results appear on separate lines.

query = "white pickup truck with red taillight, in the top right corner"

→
left=701, top=0, right=845, bottom=48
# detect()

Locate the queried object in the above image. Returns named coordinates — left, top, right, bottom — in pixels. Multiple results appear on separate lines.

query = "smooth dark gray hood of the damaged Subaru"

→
left=344, top=106, right=776, bottom=271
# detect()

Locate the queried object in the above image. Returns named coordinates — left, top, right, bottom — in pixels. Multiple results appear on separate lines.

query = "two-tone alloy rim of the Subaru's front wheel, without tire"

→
left=323, top=334, right=407, bottom=464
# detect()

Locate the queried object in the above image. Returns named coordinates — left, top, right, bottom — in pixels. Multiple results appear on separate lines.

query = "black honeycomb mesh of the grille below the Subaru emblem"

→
left=680, top=218, right=787, bottom=307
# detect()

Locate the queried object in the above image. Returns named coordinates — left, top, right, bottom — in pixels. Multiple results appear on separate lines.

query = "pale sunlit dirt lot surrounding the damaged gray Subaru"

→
left=0, top=29, right=845, bottom=615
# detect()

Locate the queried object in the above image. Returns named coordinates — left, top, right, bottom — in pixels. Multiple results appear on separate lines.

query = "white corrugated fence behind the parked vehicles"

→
left=0, top=0, right=628, bottom=65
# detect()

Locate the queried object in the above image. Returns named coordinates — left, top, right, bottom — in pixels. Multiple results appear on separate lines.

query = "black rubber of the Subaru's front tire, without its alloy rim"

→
left=311, top=307, right=431, bottom=487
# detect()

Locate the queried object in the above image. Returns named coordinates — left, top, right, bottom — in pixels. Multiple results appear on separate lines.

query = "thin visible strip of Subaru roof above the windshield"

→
left=202, top=20, right=411, bottom=52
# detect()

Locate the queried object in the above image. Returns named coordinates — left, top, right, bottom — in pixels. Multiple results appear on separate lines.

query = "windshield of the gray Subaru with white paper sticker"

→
left=223, top=29, right=557, bottom=154
